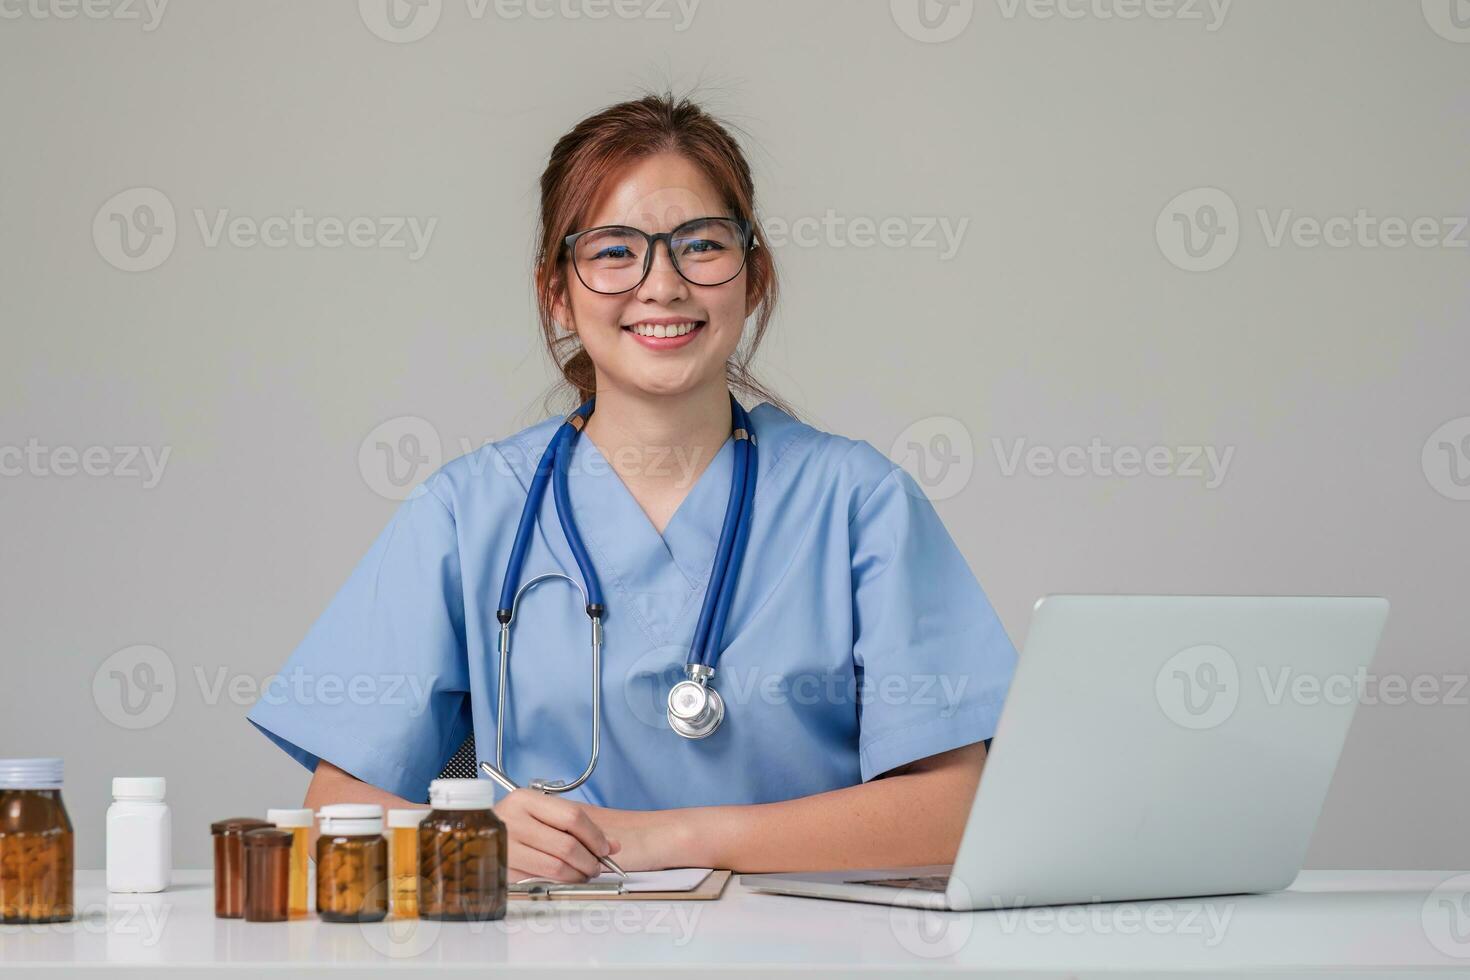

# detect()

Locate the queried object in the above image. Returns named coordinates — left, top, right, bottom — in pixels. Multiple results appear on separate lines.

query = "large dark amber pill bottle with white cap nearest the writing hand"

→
left=419, top=779, right=506, bottom=920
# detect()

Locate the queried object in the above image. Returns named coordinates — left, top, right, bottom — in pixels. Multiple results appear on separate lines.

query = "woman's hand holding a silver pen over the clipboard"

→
left=495, top=789, right=620, bottom=882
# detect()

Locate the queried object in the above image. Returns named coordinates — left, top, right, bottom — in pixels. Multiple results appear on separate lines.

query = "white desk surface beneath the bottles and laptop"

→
left=0, top=871, right=1470, bottom=980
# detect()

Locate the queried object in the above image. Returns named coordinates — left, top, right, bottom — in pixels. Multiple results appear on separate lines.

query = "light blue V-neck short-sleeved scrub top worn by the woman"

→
left=248, top=403, right=1016, bottom=810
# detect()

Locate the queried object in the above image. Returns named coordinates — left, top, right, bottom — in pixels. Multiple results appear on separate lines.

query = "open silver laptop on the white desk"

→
left=741, top=595, right=1388, bottom=909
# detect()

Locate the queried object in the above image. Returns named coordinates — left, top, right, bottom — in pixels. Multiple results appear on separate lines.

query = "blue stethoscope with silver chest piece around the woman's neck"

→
left=481, top=395, right=756, bottom=793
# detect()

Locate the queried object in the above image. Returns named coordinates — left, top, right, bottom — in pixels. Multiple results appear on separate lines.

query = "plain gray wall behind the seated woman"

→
left=0, top=0, right=1470, bottom=868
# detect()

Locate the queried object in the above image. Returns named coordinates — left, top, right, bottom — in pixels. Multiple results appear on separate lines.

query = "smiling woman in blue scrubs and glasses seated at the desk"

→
left=250, top=96, right=1016, bottom=880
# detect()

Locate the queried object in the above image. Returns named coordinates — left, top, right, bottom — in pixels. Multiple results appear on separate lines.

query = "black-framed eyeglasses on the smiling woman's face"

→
left=562, top=217, right=756, bottom=295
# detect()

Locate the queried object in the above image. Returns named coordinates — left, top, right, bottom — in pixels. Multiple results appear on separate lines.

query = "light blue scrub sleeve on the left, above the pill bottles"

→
left=248, top=485, right=470, bottom=802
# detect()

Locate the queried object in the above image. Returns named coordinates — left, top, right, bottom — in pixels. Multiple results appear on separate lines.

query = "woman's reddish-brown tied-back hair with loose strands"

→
left=535, top=91, right=795, bottom=414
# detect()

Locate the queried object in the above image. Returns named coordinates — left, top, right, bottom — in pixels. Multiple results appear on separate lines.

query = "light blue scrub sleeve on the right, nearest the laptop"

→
left=850, top=467, right=1016, bottom=780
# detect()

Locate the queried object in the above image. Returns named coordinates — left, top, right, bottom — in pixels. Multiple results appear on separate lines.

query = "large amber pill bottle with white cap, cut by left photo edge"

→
left=0, top=758, right=76, bottom=923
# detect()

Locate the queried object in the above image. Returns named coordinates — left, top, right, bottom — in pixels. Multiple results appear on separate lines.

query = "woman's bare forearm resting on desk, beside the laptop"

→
left=594, top=743, right=985, bottom=871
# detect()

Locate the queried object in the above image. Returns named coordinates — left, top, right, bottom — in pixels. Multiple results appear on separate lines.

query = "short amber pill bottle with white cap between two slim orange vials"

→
left=316, top=804, right=388, bottom=923
